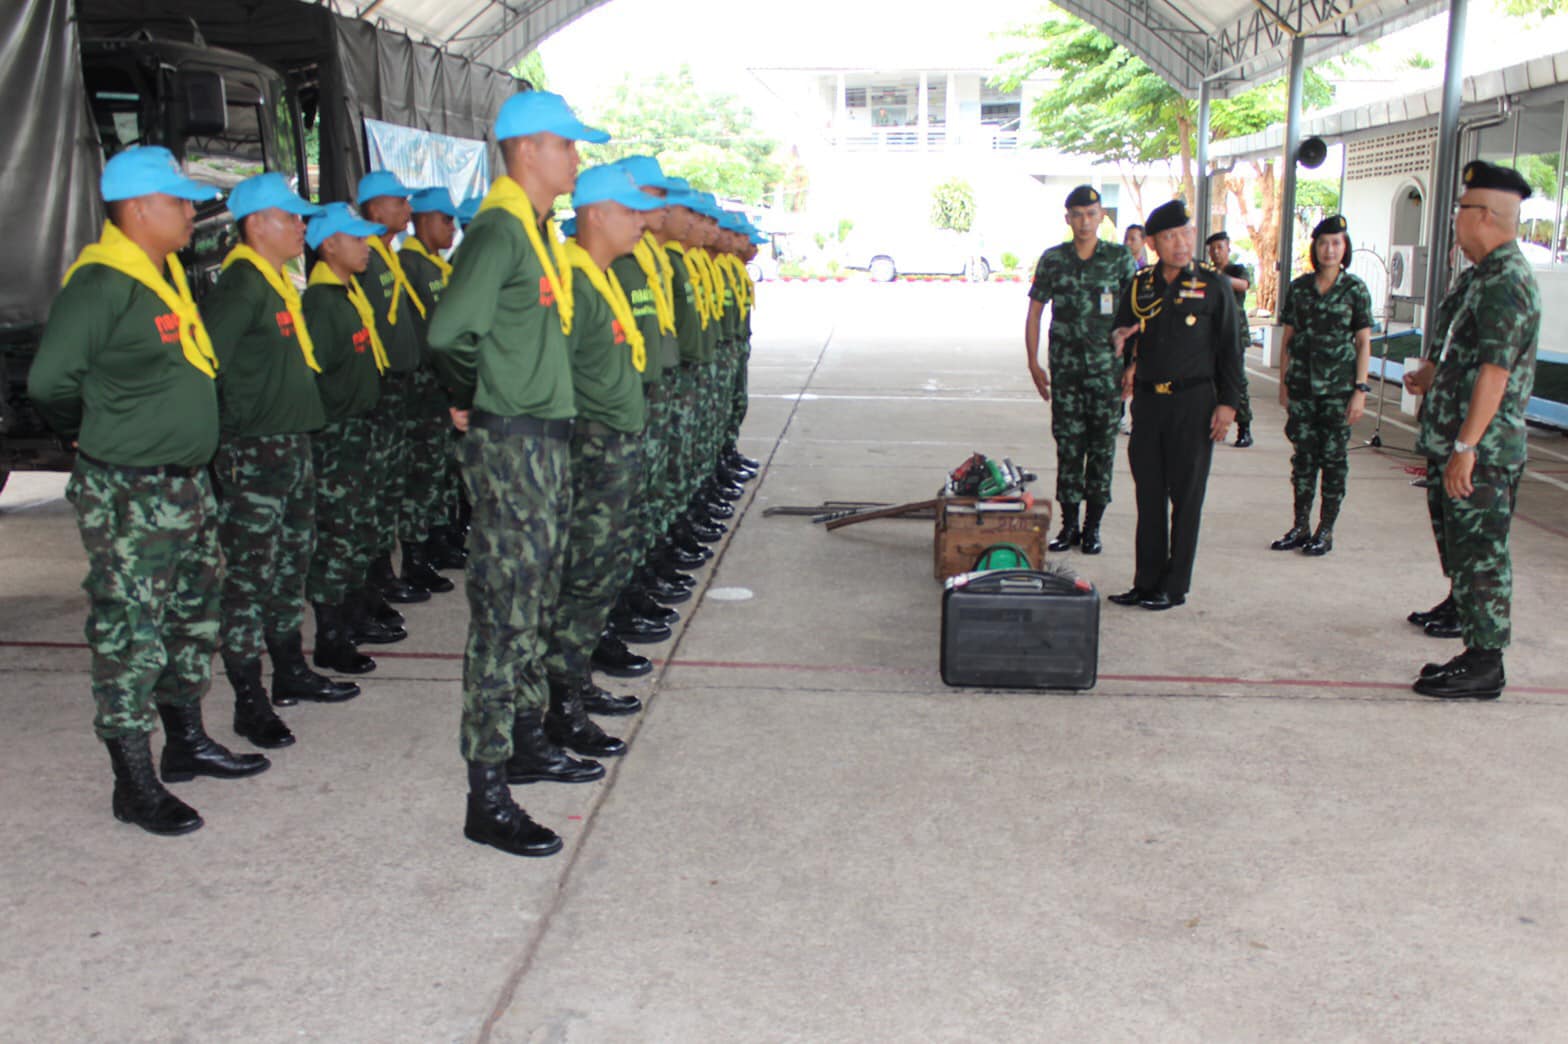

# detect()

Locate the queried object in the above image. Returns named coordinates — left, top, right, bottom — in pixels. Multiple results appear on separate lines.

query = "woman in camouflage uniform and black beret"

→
left=1270, top=215, right=1372, bottom=556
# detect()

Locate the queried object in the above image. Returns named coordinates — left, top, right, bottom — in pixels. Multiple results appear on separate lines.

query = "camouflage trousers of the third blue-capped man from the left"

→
left=306, top=417, right=386, bottom=605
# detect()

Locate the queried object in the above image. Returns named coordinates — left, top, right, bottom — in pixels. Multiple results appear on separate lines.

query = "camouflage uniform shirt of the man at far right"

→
left=1416, top=243, right=1541, bottom=467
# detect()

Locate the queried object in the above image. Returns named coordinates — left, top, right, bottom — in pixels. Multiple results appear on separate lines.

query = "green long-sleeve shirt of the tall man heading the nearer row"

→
left=430, top=208, right=577, bottom=420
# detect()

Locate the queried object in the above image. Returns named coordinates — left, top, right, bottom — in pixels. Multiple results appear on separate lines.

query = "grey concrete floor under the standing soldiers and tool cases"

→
left=0, top=284, right=1568, bottom=1042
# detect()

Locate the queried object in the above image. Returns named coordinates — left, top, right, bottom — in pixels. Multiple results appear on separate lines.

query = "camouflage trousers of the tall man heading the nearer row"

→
left=459, top=428, right=572, bottom=765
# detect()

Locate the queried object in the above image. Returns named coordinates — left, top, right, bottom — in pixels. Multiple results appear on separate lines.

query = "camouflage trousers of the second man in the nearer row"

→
left=544, top=420, right=643, bottom=682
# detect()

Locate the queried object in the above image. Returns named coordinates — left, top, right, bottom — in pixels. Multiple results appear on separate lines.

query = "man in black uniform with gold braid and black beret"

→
left=1110, top=199, right=1242, bottom=610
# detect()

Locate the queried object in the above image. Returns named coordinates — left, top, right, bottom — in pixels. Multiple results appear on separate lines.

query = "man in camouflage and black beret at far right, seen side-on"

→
left=1405, top=160, right=1541, bottom=699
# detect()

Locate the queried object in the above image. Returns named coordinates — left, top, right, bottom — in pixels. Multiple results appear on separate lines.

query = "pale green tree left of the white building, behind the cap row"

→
left=583, top=66, right=801, bottom=205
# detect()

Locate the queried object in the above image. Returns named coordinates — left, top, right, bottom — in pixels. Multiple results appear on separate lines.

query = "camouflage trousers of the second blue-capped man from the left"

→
left=212, top=434, right=315, bottom=662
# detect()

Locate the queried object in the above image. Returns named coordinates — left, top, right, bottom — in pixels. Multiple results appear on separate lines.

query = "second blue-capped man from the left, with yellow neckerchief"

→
left=202, top=174, right=359, bottom=748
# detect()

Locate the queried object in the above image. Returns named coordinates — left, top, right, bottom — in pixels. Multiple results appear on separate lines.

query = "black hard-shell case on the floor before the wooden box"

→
left=942, top=564, right=1099, bottom=690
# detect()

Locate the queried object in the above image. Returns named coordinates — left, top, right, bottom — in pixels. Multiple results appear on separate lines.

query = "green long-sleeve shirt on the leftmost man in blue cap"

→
left=27, top=265, right=218, bottom=467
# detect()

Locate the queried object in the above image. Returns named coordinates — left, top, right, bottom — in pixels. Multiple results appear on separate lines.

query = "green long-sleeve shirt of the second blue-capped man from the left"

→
left=201, top=262, right=326, bottom=437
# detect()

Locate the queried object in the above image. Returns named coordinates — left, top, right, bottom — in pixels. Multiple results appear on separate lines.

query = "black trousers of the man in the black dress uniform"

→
left=1127, top=384, right=1215, bottom=597
